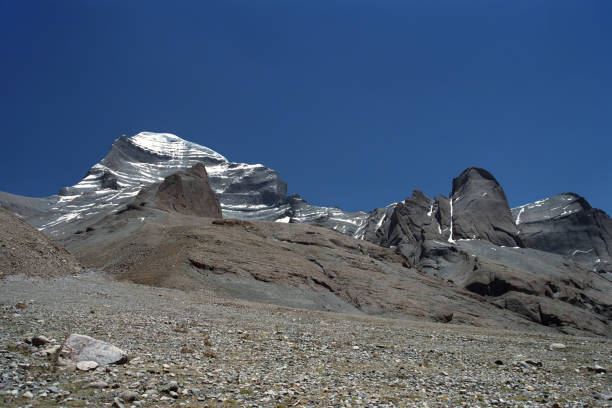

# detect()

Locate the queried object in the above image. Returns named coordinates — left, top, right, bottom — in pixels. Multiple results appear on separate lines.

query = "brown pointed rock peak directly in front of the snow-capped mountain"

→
left=132, top=163, right=222, bottom=218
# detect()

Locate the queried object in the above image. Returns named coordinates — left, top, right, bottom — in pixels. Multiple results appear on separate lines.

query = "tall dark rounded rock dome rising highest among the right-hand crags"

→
left=450, top=167, right=521, bottom=247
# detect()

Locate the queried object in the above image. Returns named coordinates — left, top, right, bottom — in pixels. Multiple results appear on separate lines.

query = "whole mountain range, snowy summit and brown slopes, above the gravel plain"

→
left=0, top=132, right=612, bottom=336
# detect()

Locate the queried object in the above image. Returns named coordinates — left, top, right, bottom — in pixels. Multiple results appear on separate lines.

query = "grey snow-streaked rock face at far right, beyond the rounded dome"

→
left=512, top=193, right=612, bottom=274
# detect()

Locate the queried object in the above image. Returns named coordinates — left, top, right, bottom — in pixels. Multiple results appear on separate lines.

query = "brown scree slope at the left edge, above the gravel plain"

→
left=0, top=208, right=82, bottom=278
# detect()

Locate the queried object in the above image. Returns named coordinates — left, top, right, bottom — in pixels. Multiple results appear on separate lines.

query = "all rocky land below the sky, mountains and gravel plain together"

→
left=0, top=133, right=612, bottom=408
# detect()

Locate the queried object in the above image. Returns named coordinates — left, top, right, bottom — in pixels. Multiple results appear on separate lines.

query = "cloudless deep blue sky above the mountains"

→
left=0, top=0, right=612, bottom=214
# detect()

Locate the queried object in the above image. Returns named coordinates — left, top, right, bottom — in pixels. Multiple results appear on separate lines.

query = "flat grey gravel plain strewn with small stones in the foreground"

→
left=0, top=272, right=612, bottom=408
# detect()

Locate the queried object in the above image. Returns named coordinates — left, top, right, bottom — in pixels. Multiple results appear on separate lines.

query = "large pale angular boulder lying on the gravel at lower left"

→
left=60, top=334, right=128, bottom=365
